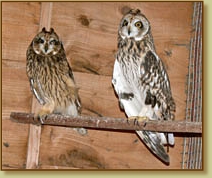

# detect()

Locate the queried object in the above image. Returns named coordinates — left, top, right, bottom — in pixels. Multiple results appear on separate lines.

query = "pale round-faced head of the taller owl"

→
left=118, top=9, right=150, bottom=41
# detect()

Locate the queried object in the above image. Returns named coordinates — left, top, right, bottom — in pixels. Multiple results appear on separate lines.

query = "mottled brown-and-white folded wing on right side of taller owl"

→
left=140, top=51, right=176, bottom=120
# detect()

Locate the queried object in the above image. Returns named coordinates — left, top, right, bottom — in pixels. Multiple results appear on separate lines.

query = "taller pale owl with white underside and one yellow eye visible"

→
left=112, top=9, right=176, bottom=164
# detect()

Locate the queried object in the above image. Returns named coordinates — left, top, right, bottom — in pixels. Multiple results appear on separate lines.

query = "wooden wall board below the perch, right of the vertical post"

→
left=40, top=126, right=182, bottom=169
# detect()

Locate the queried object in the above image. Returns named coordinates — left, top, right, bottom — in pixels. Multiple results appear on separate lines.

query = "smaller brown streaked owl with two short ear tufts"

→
left=26, top=27, right=85, bottom=134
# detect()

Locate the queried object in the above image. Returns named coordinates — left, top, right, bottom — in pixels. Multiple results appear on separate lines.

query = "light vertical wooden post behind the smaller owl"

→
left=26, top=2, right=53, bottom=169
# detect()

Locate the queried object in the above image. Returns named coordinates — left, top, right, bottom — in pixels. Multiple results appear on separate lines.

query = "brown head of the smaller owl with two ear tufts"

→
left=32, top=27, right=62, bottom=55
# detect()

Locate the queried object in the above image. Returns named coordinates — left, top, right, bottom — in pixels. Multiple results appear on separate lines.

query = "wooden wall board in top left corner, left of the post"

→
left=2, top=2, right=40, bottom=62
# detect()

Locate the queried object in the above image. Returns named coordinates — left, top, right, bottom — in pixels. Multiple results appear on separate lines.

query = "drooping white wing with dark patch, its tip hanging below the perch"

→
left=112, top=56, right=172, bottom=164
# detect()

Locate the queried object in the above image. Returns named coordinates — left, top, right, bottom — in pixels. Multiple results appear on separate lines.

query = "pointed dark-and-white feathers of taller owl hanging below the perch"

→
left=136, top=131, right=169, bottom=164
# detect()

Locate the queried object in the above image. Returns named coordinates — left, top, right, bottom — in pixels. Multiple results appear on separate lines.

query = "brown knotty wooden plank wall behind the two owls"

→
left=2, top=2, right=193, bottom=169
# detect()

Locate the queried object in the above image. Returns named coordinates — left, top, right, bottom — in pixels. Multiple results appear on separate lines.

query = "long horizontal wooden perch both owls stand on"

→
left=10, top=112, right=202, bottom=133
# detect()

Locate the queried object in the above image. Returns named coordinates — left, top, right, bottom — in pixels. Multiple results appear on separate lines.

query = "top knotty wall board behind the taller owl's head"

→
left=52, top=2, right=193, bottom=75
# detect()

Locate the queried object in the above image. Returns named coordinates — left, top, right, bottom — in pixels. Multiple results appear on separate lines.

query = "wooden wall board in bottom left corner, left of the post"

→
left=1, top=117, right=29, bottom=170
